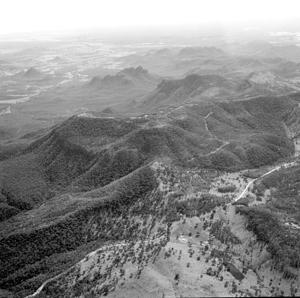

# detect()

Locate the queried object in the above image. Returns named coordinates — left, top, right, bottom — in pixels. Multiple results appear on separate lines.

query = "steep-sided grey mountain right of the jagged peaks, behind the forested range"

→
left=140, top=68, right=300, bottom=111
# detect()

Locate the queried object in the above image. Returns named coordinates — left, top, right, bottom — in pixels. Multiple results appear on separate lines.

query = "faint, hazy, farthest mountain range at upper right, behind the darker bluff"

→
left=120, top=43, right=300, bottom=78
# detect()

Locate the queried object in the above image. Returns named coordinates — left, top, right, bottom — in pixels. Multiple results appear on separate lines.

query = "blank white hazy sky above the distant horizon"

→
left=0, top=0, right=300, bottom=34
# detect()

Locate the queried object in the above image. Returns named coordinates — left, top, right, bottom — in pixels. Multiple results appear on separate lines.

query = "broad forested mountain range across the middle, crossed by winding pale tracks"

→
left=0, top=97, right=296, bottom=218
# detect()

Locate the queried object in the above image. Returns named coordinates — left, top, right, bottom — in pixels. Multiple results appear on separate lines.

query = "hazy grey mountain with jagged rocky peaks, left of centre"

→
left=40, top=67, right=161, bottom=117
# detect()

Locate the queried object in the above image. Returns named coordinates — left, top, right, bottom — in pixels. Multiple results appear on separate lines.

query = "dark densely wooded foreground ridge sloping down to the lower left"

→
left=0, top=167, right=156, bottom=297
